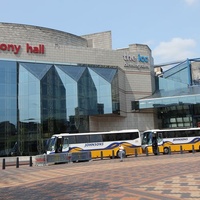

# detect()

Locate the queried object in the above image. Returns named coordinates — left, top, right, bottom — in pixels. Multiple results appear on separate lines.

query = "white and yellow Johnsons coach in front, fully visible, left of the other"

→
left=46, top=129, right=142, bottom=158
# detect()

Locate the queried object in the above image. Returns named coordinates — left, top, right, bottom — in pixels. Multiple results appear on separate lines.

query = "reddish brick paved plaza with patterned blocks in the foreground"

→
left=0, top=153, right=200, bottom=200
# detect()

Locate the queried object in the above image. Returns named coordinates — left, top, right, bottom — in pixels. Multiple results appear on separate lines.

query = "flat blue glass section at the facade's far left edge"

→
left=0, top=61, right=17, bottom=156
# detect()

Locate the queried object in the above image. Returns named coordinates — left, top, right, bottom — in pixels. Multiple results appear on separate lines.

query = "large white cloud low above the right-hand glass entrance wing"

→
left=152, top=38, right=196, bottom=63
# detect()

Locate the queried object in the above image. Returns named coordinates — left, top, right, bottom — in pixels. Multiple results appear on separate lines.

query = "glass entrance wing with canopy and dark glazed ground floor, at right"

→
left=136, top=58, right=200, bottom=128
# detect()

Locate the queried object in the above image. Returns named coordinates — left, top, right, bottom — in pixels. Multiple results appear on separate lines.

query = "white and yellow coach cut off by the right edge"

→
left=142, top=128, right=200, bottom=155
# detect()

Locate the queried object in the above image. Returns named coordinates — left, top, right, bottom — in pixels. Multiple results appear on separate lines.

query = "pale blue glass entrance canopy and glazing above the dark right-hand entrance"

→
left=135, top=58, right=200, bottom=110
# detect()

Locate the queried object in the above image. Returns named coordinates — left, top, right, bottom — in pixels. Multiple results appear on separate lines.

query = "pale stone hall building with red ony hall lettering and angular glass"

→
left=0, top=23, right=199, bottom=156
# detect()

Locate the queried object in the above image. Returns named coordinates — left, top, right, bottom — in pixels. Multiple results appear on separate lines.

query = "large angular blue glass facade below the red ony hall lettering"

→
left=0, top=61, right=119, bottom=156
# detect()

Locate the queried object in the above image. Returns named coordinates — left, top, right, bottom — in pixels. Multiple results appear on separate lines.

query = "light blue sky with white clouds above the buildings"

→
left=0, top=0, right=200, bottom=64
